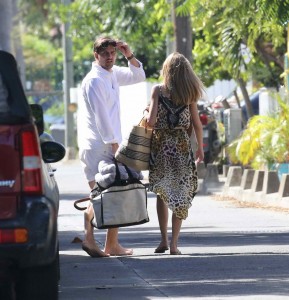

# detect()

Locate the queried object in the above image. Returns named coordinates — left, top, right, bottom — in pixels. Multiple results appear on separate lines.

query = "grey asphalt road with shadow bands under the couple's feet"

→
left=56, top=161, right=289, bottom=300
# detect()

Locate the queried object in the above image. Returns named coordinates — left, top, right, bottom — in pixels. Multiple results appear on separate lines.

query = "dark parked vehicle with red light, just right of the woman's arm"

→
left=198, top=102, right=222, bottom=165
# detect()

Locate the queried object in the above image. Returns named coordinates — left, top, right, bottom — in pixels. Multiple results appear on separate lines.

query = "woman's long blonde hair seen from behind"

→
left=161, top=52, right=204, bottom=105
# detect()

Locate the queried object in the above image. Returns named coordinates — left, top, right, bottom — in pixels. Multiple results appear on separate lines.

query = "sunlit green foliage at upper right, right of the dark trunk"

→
left=177, top=0, right=289, bottom=86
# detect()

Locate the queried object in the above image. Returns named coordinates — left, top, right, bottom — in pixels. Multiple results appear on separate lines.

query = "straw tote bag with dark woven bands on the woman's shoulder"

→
left=115, top=118, right=153, bottom=171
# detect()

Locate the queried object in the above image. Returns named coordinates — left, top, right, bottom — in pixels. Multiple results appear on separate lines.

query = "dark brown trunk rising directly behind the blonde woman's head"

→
left=173, top=1, right=193, bottom=63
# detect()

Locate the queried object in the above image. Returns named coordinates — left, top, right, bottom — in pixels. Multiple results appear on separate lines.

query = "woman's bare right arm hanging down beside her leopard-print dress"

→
left=190, top=102, right=204, bottom=162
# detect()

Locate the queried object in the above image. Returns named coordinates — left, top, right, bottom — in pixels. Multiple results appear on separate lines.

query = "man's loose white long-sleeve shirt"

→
left=77, top=62, right=146, bottom=149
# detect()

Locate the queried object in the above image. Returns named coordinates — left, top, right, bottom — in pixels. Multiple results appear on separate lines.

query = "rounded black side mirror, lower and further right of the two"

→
left=40, top=141, right=65, bottom=163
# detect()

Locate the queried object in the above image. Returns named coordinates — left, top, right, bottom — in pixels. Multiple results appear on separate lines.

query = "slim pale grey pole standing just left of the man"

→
left=62, top=0, right=76, bottom=159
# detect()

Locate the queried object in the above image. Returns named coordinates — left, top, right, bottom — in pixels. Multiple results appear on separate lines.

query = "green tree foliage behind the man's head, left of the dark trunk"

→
left=51, top=0, right=169, bottom=82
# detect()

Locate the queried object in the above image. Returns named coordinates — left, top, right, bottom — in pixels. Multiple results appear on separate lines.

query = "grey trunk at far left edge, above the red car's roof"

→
left=0, top=0, right=12, bottom=52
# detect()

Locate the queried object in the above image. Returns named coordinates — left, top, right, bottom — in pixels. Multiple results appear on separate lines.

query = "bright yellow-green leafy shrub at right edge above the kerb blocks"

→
left=227, top=96, right=289, bottom=169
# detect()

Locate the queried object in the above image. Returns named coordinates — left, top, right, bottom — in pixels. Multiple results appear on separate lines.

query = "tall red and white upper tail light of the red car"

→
left=21, top=130, right=43, bottom=195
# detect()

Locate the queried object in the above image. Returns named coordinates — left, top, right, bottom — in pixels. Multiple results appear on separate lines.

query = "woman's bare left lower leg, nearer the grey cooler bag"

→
left=155, top=196, right=169, bottom=253
